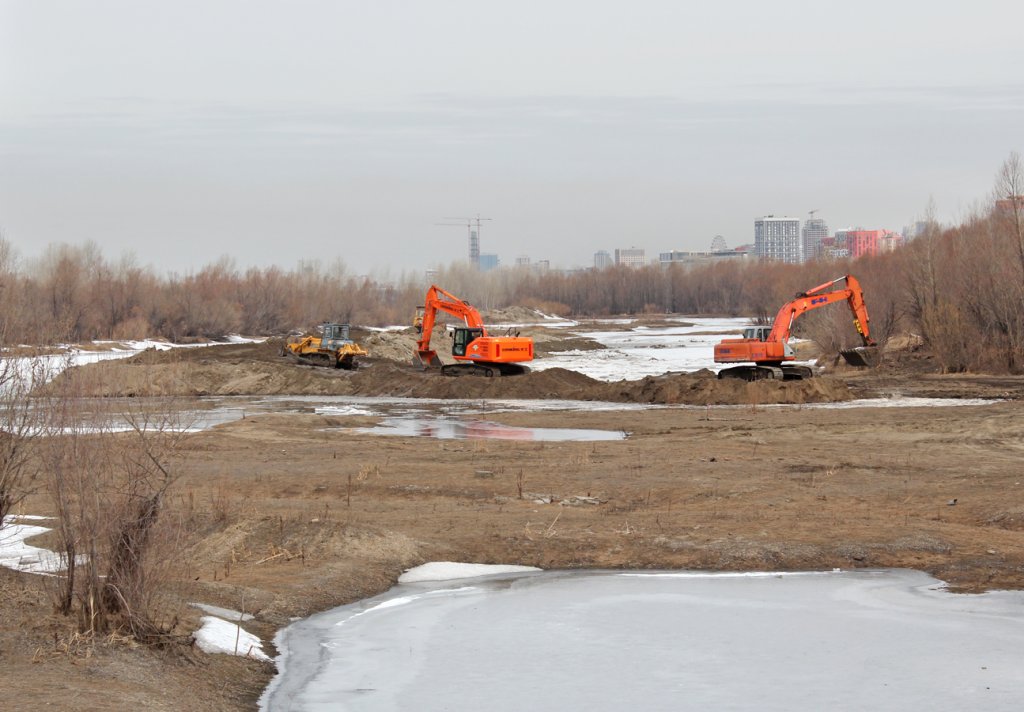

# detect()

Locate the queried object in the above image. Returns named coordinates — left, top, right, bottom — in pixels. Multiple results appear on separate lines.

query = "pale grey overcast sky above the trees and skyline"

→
left=0, top=0, right=1024, bottom=276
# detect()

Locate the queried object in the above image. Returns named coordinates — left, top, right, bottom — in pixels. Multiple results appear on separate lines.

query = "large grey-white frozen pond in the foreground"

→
left=261, top=571, right=1024, bottom=712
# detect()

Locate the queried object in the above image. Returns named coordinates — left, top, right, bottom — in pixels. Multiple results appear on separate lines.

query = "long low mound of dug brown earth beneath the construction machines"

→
left=57, top=334, right=852, bottom=406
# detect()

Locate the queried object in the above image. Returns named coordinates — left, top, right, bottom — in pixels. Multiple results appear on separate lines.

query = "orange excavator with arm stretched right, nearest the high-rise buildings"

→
left=715, top=275, right=878, bottom=381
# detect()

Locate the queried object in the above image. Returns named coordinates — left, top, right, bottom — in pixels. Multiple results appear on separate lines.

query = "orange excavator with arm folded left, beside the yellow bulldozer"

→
left=413, top=285, right=534, bottom=377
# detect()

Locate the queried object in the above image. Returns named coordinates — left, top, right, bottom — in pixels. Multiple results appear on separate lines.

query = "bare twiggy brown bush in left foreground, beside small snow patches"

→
left=41, top=362, right=192, bottom=641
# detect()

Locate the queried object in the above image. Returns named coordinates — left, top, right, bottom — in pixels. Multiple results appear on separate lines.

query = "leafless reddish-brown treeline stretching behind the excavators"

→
left=0, top=154, right=1024, bottom=372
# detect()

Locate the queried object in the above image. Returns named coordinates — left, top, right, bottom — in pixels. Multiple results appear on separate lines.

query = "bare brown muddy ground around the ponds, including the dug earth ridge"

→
left=0, top=321, right=1024, bottom=711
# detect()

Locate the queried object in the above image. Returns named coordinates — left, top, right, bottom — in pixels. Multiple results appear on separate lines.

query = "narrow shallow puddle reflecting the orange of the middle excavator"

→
left=344, top=416, right=626, bottom=442
